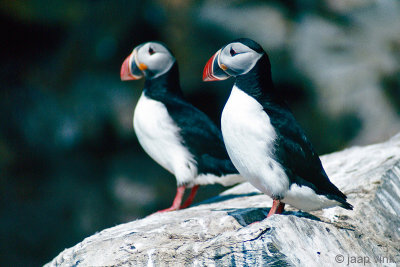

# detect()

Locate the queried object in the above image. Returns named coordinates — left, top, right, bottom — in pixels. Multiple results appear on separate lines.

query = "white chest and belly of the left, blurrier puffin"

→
left=133, top=94, right=197, bottom=183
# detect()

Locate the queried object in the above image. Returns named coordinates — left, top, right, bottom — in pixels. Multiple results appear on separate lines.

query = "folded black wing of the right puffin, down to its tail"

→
left=264, top=105, right=351, bottom=208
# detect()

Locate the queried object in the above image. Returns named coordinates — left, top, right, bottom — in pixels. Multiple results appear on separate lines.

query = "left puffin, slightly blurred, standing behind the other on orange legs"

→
left=120, top=42, right=244, bottom=212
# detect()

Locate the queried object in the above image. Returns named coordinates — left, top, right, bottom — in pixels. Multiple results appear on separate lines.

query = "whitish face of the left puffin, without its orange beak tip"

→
left=132, top=42, right=175, bottom=78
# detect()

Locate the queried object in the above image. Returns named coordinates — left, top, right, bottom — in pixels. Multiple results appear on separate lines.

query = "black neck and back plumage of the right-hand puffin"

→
left=235, top=52, right=352, bottom=209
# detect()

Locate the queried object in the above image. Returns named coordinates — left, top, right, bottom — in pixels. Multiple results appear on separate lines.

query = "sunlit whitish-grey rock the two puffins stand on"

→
left=46, top=134, right=400, bottom=266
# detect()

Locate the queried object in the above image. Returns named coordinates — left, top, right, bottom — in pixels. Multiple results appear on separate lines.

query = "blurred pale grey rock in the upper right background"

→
left=290, top=0, right=400, bottom=144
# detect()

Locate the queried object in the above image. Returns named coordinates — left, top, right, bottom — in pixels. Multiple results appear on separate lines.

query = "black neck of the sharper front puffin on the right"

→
left=235, top=53, right=275, bottom=103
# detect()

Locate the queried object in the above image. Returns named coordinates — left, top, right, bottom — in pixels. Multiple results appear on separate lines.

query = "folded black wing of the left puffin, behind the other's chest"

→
left=163, top=97, right=238, bottom=176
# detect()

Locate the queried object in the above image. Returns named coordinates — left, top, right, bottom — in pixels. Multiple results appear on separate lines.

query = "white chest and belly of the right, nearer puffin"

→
left=221, top=86, right=289, bottom=199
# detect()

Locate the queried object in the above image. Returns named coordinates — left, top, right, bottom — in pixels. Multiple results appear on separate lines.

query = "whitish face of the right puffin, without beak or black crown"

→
left=218, top=43, right=262, bottom=76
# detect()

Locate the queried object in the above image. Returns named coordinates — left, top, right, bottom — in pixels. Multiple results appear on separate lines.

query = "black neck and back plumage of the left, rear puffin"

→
left=143, top=62, right=238, bottom=176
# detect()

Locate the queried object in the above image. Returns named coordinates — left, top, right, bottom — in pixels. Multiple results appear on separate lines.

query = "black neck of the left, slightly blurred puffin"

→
left=143, top=62, right=183, bottom=99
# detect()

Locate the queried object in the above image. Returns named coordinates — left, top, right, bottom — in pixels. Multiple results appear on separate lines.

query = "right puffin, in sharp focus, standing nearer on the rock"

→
left=203, top=38, right=353, bottom=218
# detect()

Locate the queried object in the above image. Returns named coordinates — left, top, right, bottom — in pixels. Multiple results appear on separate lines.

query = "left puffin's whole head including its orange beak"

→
left=120, top=42, right=175, bottom=81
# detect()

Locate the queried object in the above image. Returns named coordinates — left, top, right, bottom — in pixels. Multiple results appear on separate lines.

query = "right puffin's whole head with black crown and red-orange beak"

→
left=203, top=38, right=265, bottom=82
